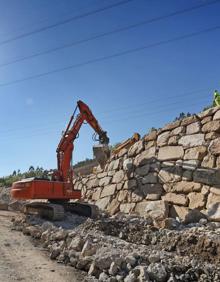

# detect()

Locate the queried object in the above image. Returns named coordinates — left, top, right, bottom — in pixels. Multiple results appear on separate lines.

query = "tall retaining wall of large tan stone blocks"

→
left=74, top=107, right=220, bottom=220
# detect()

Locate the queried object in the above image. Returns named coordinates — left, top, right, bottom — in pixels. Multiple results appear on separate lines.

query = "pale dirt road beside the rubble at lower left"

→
left=0, top=211, right=83, bottom=282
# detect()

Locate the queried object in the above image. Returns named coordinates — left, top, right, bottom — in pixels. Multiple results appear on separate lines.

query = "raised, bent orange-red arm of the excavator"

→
left=53, top=101, right=109, bottom=181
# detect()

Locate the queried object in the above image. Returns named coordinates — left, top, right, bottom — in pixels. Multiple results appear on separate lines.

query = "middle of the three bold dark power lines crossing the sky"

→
left=0, top=0, right=220, bottom=67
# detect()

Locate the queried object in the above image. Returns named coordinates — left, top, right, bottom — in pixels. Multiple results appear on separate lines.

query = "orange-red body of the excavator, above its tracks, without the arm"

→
left=11, top=178, right=81, bottom=200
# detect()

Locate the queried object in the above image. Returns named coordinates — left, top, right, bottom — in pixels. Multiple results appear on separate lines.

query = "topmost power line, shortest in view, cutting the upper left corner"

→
left=0, top=0, right=134, bottom=45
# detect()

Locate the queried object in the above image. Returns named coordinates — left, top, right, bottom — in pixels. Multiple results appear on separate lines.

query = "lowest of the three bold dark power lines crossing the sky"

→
left=0, top=25, right=220, bottom=87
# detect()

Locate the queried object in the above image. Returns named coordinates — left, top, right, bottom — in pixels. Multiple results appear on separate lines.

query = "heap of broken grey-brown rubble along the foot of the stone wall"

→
left=13, top=214, right=220, bottom=282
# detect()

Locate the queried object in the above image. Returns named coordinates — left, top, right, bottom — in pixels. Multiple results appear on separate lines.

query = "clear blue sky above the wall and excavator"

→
left=0, top=0, right=220, bottom=176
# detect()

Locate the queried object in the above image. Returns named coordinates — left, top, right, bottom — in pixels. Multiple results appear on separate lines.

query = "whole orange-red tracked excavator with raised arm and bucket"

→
left=11, top=101, right=110, bottom=220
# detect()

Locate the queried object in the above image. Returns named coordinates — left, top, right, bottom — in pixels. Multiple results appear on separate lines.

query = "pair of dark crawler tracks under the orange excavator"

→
left=24, top=202, right=99, bottom=221
